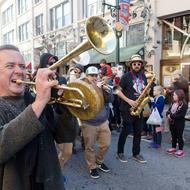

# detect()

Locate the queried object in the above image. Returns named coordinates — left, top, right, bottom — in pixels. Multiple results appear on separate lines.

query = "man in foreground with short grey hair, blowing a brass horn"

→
left=0, top=45, right=76, bottom=190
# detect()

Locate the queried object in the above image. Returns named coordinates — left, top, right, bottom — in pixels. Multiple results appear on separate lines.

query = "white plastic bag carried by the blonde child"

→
left=146, top=108, right=163, bottom=125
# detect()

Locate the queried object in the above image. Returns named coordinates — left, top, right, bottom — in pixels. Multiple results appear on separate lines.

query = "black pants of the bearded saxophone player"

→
left=117, top=112, right=142, bottom=156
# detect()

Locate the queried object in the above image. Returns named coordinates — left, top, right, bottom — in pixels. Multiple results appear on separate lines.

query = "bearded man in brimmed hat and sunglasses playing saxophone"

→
left=117, top=55, right=147, bottom=163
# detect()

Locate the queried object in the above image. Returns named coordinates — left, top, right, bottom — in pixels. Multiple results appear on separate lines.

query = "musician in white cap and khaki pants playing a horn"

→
left=81, top=66, right=111, bottom=179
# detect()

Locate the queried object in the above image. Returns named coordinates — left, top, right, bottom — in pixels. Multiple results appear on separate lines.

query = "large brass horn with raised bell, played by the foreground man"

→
left=31, top=16, right=116, bottom=120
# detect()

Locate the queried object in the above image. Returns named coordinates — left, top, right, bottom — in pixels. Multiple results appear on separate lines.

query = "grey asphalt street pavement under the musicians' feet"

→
left=63, top=127, right=190, bottom=190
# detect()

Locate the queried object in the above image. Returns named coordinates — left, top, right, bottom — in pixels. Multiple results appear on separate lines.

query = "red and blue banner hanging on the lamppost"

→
left=119, top=0, right=130, bottom=31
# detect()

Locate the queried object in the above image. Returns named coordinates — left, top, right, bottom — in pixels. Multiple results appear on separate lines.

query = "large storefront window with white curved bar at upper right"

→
left=162, top=15, right=190, bottom=59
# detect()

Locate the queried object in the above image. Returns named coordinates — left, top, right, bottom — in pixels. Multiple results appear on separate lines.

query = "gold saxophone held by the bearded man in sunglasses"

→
left=130, top=74, right=155, bottom=116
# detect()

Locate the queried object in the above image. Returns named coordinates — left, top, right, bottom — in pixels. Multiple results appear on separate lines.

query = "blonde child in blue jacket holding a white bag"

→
left=150, top=86, right=165, bottom=148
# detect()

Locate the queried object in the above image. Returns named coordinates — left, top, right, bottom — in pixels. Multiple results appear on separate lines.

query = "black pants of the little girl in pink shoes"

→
left=170, top=125, right=184, bottom=150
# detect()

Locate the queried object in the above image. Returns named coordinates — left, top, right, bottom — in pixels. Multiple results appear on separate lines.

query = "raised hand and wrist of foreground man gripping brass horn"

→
left=32, top=68, right=58, bottom=117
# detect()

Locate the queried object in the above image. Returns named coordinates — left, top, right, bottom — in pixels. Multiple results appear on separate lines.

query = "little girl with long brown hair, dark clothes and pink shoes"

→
left=166, top=89, right=188, bottom=158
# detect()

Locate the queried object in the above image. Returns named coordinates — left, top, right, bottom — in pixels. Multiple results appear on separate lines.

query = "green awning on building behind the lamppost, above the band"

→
left=88, top=44, right=144, bottom=64
